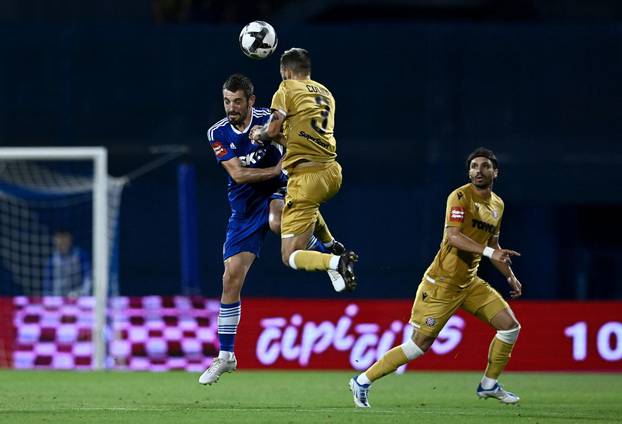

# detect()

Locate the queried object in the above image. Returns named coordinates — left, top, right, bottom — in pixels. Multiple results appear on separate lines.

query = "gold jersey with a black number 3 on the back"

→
left=270, top=80, right=337, bottom=170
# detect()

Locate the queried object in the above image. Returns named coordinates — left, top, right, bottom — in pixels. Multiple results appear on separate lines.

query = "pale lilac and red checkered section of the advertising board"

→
left=8, top=296, right=220, bottom=371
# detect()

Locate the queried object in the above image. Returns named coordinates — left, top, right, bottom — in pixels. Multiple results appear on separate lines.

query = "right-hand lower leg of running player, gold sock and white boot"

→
left=477, top=306, right=520, bottom=404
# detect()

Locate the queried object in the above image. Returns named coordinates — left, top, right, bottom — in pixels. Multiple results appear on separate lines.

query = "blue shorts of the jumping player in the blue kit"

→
left=222, top=192, right=284, bottom=261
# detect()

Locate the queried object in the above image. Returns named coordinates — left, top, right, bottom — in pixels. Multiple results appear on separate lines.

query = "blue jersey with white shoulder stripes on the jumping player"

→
left=207, top=108, right=287, bottom=218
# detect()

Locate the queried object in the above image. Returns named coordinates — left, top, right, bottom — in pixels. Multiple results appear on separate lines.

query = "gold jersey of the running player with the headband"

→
left=426, top=183, right=504, bottom=288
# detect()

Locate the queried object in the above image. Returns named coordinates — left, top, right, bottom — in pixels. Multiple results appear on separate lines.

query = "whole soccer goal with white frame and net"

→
left=0, top=147, right=124, bottom=369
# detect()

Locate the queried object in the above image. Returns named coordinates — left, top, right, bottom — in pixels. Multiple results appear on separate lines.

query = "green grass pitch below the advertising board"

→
left=0, top=370, right=622, bottom=424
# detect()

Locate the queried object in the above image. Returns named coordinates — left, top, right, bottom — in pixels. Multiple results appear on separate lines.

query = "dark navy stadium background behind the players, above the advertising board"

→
left=0, top=0, right=622, bottom=299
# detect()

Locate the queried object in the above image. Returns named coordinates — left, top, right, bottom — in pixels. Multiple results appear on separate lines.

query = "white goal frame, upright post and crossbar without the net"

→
left=0, top=147, right=110, bottom=369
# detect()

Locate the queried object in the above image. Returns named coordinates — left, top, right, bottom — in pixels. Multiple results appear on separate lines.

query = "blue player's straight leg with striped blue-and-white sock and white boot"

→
left=199, top=252, right=255, bottom=384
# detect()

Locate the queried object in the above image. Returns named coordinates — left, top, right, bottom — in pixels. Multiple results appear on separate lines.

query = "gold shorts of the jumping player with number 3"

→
left=281, top=161, right=341, bottom=238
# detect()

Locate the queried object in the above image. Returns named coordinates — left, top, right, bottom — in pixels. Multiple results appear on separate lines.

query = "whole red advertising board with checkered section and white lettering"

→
left=0, top=296, right=622, bottom=372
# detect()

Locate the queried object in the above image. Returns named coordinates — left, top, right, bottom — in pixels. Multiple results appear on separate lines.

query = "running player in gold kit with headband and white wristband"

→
left=349, top=147, right=522, bottom=408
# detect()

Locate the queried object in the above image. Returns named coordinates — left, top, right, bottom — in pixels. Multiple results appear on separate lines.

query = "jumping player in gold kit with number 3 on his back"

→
left=250, top=48, right=358, bottom=291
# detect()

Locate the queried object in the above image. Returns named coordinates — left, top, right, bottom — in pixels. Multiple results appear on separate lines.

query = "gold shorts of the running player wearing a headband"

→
left=410, top=275, right=510, bottom=337
